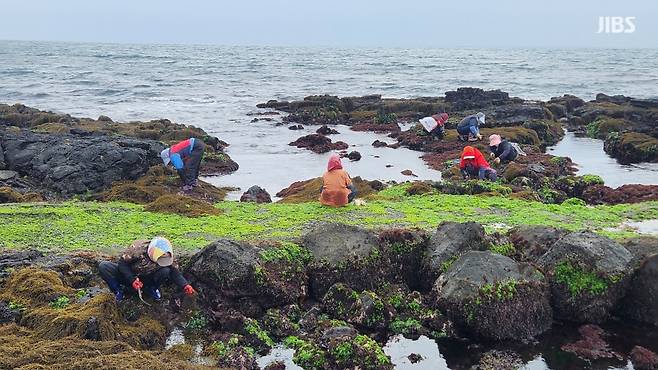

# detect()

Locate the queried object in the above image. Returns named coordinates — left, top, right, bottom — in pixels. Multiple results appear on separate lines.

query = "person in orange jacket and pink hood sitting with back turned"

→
left=320, top=154, right=357, bottom=207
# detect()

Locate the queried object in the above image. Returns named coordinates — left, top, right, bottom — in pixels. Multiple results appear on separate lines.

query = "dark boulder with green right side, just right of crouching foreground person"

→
left=185, top=239, right=310, bottom=314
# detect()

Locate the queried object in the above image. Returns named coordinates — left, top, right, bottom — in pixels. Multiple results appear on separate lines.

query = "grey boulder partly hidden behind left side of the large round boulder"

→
left=422, top=221, right=489, bottom=289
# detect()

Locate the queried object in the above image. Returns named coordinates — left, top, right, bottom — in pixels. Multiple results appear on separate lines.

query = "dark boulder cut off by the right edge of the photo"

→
left=621, top=252, right=658, bottom=326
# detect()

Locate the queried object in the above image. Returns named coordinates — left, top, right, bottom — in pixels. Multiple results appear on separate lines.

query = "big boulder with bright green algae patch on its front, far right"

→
left=537, top=231, right=633, bottom=323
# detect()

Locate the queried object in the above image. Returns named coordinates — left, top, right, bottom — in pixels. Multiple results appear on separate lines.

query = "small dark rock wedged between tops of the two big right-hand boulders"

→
left=508, top=226, right=568, bottom=263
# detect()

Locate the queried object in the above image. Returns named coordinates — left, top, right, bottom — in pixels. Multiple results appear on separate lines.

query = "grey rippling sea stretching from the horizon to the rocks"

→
left=0, top=41, right=658, bottom=192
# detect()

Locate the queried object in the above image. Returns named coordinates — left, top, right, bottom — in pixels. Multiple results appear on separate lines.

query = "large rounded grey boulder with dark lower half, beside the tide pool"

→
left=434, top=251, right=553, bottom=340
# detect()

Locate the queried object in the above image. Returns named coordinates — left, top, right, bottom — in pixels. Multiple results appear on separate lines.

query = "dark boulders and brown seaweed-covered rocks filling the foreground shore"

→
left=0, top=222, right=658, bottom=369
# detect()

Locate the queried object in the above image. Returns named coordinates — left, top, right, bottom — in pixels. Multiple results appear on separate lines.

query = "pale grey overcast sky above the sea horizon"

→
left=0, top=0, right=658, bottom=48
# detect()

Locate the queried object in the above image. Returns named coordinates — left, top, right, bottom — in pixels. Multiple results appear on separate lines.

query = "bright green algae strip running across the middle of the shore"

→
left=0, top=184, right=658, bottom=250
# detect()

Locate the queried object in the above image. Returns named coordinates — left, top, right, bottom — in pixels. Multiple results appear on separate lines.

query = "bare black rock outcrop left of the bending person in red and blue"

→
left=0, top=131, right=164, bottom=195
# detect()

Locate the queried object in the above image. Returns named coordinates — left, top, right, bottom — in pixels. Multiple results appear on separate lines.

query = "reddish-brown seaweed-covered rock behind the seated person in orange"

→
left=276, top=176, right=383, bottom=203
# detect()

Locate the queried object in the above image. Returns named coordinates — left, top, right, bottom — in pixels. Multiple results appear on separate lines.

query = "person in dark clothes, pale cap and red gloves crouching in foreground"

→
left=98, top=237, right=195, bottom=302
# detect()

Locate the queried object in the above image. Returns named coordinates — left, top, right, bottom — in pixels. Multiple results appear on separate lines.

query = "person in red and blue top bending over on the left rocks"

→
left=160, top=138, right=205, bottom=193
